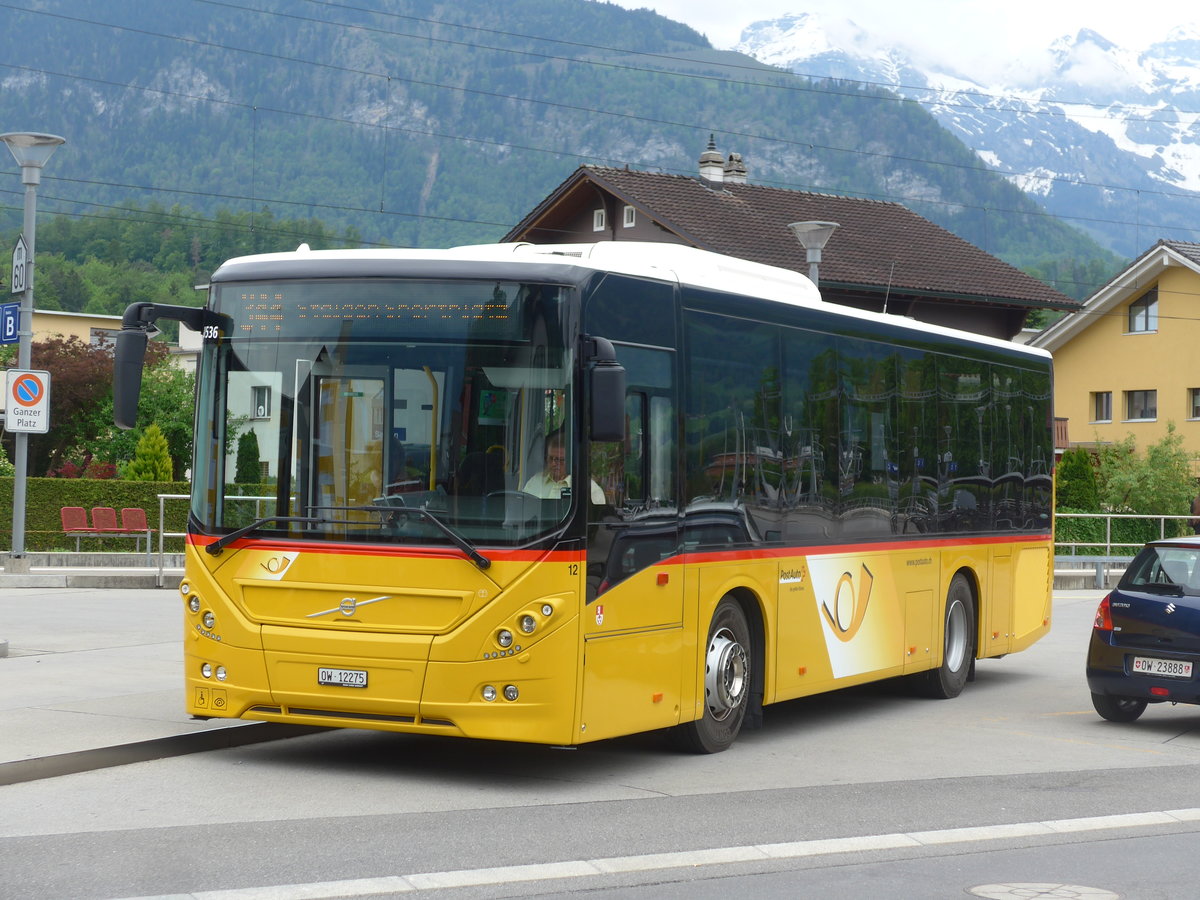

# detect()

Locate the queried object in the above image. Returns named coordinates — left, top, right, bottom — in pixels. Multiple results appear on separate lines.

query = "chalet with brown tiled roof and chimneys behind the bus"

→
left=504, top=140, right=1080, bottom=340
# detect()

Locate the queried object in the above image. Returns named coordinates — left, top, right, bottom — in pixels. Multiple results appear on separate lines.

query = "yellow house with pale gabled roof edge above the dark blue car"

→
left=1030, top=240, right=1200, bottom=457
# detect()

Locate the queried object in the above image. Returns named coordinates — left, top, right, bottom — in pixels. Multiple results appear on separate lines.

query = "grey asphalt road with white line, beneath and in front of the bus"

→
left=0, top=592, right=1200, bottom=900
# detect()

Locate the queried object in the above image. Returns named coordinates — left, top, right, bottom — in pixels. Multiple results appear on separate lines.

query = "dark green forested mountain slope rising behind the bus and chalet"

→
left=0, top=0, right=1111, bottom=296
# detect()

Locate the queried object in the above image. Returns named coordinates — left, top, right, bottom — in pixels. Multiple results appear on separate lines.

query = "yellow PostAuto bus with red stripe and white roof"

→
left=115, top=242, right=1054, bottom=752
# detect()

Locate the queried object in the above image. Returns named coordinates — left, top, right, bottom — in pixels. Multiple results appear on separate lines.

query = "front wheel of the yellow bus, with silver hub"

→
left=671, top=596, right=754, bottom=754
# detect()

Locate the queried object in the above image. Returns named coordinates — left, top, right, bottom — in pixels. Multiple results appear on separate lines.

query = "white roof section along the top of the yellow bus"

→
left=221, top=241, right=1050, bottom=367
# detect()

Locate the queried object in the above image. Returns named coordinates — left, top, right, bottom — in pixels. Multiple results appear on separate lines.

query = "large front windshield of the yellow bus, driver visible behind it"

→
left=192, top=278, right=577, bottom=546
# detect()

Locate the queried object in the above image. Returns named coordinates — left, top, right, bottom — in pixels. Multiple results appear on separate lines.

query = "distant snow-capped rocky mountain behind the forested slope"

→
left=734, top=14, right=1200, bottom=257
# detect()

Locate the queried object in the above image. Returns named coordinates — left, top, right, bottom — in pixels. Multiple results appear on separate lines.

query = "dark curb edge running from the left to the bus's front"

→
left=0, top=722, right=329, bottom=786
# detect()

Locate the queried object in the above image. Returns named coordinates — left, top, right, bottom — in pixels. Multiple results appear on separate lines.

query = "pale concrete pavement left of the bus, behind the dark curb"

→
left=0, top=554, right=312, bottom=785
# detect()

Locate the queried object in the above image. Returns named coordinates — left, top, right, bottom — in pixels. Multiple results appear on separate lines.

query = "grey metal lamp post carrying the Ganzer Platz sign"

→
left=0, top=132, right=66, bottom=571
